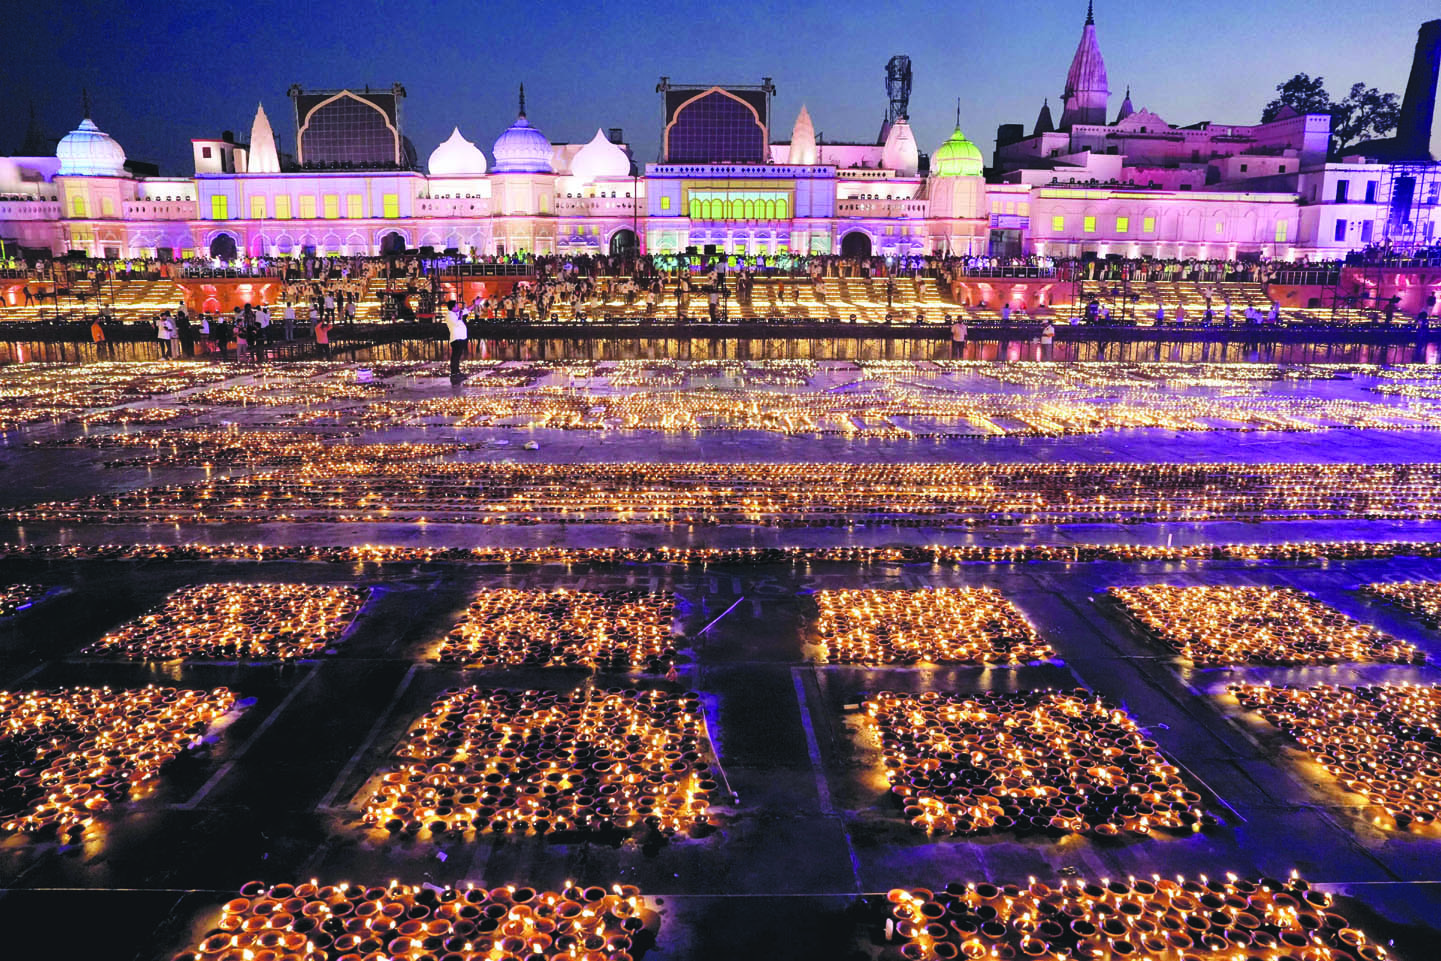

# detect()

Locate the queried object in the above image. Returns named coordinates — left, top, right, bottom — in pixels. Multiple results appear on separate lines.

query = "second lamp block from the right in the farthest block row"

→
left=1110, top=585, right=1425, bottom=667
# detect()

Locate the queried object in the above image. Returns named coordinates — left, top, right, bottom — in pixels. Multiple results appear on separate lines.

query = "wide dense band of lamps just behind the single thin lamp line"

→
left=16, top=462, right=1441, bottom=526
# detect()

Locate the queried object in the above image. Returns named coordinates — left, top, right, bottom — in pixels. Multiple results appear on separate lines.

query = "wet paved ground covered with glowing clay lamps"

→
left=0, top=362, right=1441, bottom=961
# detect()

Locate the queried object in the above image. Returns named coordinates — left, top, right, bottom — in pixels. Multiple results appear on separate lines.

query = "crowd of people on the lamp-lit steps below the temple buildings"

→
left=0, top=248, right=1441, bottom=351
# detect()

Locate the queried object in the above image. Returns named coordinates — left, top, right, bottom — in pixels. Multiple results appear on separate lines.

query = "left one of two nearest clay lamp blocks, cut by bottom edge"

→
left=174, top=880, right=660, bottom=961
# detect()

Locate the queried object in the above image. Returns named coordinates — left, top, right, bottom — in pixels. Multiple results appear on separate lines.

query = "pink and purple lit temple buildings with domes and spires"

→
left=0, top=10, right=1441, bottom=261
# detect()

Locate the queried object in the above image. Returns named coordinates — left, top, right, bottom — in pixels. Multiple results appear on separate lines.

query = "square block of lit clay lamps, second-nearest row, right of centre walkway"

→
left=862, top=690, right=1215, bottom=839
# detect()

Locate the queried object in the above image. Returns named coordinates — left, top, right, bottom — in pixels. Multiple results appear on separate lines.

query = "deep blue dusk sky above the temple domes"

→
left=11, top=0, right=1438, bottom=174
